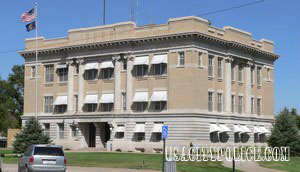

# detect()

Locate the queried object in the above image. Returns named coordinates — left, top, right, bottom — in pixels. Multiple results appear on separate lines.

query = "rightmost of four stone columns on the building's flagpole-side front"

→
left=126, top=56, right=133, bottom=112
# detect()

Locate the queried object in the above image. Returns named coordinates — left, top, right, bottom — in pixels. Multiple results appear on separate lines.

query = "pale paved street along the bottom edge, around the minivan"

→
left=3, top=164, right=155, bottom=172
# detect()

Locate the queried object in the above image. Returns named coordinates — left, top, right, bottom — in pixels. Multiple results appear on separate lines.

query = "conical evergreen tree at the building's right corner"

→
left=268, top=108, right=300, bottom=155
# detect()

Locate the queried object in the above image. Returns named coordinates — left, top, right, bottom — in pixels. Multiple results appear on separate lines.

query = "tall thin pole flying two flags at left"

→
left=34, top=1, right=38, bottom=118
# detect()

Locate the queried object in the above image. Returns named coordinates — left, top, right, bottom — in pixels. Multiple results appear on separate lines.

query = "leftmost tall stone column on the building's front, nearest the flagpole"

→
left=67, top=60, right=74, bottom=114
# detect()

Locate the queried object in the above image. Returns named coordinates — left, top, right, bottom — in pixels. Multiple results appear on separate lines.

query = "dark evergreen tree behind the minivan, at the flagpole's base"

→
left=12, top=117, right=52, bottom=153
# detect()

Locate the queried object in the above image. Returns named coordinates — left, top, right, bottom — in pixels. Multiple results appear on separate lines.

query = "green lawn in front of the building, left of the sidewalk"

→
left=0, top=150, right=231, bottom=172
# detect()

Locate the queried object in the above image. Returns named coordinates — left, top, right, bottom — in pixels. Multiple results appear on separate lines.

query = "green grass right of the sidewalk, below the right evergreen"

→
left=259, top=157, right=300, bottom=172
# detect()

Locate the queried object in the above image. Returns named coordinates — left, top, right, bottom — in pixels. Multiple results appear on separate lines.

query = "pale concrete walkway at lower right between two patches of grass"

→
left=222, top=158, right=283, bottom=172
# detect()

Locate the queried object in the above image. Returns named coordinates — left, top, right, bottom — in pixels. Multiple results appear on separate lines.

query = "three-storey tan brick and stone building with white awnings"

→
left=20, top=16, right=279, bottom=152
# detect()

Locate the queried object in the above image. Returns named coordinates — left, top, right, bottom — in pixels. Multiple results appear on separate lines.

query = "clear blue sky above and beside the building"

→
left=0, top=0, right=300, bottom=113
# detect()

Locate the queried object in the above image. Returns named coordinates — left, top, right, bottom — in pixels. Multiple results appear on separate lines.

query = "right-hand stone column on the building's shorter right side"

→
left=245, top=62, right=253, bottom=114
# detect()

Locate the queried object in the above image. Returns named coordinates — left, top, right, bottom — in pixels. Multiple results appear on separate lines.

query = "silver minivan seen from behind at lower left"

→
left=18, top=145, right=67, bottom=172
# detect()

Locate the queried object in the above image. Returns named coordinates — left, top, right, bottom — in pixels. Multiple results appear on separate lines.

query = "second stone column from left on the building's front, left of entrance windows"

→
left=77, top=59, right=84, bottom=112
